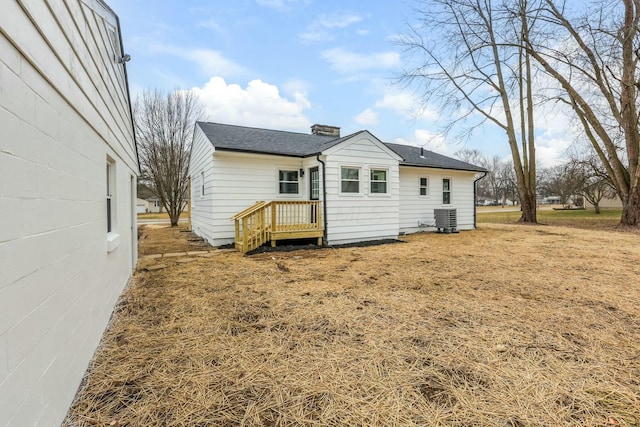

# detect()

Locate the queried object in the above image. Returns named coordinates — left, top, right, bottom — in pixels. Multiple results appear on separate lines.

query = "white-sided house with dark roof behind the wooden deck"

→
left=189, top=122, right=484, bottom=251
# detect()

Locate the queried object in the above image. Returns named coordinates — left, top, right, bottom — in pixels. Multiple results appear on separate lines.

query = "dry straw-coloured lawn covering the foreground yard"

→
left=65, top=224, right=640, bottom=426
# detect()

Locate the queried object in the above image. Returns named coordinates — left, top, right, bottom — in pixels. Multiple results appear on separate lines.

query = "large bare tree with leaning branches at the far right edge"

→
left=524, top=0, right=640, bottom=226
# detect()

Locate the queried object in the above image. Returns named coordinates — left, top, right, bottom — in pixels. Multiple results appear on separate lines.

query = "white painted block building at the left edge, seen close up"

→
left=0, top=0, right=138, bottom=426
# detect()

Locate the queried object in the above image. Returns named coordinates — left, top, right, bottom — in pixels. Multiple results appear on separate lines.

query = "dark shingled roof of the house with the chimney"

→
left=197, top=122, right=485, bottom=172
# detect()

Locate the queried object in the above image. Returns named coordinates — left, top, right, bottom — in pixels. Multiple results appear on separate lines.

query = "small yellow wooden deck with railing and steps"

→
left=231, top=200, right=324, bottom=253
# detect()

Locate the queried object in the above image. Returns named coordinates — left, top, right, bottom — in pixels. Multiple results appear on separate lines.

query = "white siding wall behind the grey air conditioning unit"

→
left=400, top=167, right=475, bottom=233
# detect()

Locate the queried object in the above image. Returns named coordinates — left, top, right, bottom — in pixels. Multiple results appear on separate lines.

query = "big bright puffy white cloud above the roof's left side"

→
left=192, top=77, right=311, bottom=131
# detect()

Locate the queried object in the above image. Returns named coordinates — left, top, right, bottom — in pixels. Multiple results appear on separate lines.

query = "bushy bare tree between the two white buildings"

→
left=134, top=90, right=203, bottom=227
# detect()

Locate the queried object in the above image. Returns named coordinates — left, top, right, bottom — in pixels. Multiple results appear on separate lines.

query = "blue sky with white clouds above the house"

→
left=107, top=0, right=567, bottom=163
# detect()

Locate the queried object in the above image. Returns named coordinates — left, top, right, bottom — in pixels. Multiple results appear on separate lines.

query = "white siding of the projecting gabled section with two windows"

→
left=326, top=133, right=399, bottom=244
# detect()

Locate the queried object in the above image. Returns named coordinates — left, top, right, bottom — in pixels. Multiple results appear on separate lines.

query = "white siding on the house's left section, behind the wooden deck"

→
left=191, top=147, right=307, bottom=246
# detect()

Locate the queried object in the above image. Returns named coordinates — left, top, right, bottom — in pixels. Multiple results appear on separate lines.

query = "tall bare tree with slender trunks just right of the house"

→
left=399, top=0, right=536, bottom=223
